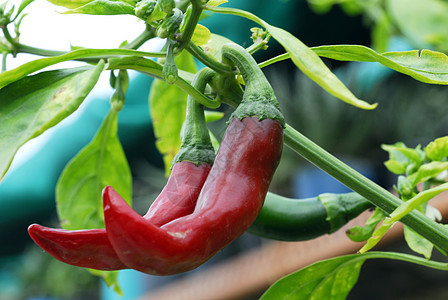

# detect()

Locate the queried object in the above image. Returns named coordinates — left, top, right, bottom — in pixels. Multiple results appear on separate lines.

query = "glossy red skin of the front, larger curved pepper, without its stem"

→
left=103, top=117, right=283, bottom=275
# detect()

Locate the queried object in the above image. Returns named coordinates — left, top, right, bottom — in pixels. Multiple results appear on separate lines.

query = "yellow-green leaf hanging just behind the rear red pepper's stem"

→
left=149, top=51, right=196, bottom=176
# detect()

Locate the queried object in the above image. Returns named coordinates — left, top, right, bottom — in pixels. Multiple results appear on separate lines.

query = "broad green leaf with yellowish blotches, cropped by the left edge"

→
left=0, top=63, right=104, bottom=179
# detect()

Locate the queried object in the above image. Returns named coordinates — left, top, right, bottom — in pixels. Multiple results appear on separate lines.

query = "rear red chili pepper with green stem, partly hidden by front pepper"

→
left=28, top=72, right=214, bottom=270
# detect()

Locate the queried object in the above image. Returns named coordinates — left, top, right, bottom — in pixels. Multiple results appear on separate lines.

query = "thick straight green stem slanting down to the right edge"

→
left=285, top=125, right=448, bottom=252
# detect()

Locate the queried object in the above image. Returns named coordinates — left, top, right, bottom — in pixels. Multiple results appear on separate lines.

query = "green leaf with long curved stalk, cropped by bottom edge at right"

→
left=260, top=252, right=448, bottom=300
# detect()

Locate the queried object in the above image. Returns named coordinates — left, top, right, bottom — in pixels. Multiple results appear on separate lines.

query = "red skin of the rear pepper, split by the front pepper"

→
left=28, top=161, right=211, bottom=271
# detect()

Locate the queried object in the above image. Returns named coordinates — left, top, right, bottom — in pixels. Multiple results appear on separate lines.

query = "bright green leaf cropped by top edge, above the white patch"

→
left=64, top=0, right=135, bottom=15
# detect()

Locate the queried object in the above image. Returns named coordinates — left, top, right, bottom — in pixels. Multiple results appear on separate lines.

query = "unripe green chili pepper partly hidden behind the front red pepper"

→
left=248, top=193, right=373, bottom=241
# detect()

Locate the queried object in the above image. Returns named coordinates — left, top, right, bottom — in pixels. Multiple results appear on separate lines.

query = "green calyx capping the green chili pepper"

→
left=318, top=193, right=373, bottom=233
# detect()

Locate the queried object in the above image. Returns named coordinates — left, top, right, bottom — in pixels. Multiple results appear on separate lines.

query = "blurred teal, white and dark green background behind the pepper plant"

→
left=0, top=0, right=448, bottom=300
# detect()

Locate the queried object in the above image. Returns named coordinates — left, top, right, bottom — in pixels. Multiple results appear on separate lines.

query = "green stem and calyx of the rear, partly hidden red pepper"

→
left=173, top=68, right=215, bottom=165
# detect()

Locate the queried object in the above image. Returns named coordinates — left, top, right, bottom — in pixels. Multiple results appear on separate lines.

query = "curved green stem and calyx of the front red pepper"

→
left=222, top=44, right=285, bottom=127
